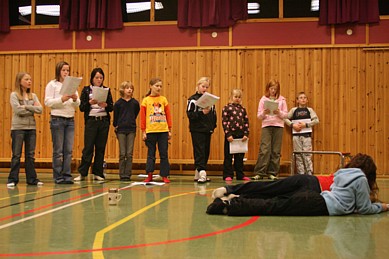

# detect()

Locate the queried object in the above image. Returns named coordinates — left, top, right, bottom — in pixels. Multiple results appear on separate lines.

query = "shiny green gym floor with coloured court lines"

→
left=0, top=170, right=389, bottom=259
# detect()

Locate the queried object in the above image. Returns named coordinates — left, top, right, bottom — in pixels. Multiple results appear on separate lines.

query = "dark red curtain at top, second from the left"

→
left=59, top=0, right=123, bottom=31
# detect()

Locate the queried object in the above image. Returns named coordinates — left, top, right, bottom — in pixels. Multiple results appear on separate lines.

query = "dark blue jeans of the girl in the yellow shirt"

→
left=145, top=132, right=170, bottom=177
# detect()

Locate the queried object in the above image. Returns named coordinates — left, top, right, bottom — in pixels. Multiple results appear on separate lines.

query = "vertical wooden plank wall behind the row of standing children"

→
left=0, top=47, right=389, bottom=175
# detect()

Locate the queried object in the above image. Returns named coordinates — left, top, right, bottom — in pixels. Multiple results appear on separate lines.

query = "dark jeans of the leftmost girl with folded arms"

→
left=8, top=130, right=39, bottom=185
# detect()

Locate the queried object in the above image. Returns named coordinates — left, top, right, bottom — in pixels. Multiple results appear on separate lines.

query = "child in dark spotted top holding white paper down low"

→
left=222, top=89, right=250, bottom=182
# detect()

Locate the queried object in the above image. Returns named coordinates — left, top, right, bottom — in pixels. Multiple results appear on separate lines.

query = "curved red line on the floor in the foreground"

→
left=0, top=216, right=259, bottom=257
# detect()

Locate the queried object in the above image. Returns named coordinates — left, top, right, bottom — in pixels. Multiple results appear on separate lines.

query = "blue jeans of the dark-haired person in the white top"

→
left=50, top=117, right=74, bottom=183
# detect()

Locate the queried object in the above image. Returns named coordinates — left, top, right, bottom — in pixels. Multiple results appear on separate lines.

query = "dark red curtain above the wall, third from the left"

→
left=178, top=0, right=248, bottom=28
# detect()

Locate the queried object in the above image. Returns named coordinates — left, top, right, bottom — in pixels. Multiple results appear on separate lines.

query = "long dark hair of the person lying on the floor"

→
left=345, top=153, right=378, bottom=202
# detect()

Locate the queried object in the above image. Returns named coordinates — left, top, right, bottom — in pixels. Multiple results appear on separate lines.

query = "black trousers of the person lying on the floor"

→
left=226, top=175, right=328, bottom=216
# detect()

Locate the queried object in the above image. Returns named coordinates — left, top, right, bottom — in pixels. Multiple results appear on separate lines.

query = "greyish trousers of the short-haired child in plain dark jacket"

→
left=116, top=132, right=136, bottom=179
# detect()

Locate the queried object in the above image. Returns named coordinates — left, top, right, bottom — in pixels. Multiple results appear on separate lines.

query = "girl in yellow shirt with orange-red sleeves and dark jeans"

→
left=140, top=78, right=173, bottom=183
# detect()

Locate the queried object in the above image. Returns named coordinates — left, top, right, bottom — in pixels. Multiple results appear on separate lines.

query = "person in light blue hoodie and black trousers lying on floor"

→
left=207, top=154, right=389, bottom=216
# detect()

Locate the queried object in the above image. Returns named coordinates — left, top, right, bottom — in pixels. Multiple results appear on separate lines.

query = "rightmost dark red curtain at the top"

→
left=319, top=0, right=380, bottom=25
